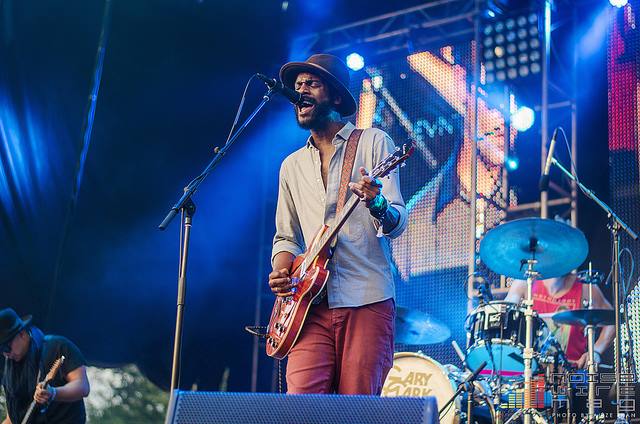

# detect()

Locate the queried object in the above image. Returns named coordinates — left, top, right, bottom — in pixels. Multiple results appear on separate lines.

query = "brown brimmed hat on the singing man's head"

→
left=280, top=54, right=356, bottom=116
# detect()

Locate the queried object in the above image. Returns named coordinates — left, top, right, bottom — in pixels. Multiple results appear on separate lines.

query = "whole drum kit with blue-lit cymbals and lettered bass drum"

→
left=382, top=218, right=615, bottom=424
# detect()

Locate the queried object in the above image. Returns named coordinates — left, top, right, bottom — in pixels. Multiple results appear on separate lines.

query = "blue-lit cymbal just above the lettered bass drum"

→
left=395, top=306, right=451, bottom=345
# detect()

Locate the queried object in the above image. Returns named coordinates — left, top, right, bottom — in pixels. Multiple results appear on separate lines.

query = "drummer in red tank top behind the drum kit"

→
left=505, top=273, right=615, bottom=368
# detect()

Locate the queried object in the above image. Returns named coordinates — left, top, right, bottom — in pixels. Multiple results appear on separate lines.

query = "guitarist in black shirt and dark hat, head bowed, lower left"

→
left=0, top=308, right=89, bottom=424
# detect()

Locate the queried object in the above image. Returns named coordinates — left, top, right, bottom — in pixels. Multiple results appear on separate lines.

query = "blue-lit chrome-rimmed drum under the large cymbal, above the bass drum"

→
left=466, top=301, right=549, bottom=379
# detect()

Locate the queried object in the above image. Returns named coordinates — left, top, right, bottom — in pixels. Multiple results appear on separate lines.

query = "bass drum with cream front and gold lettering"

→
left=382, top=352, right=493, bottom=424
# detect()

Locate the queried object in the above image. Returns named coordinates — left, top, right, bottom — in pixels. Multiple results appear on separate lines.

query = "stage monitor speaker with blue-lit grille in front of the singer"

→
left=166, top=391, right=438, bottom=424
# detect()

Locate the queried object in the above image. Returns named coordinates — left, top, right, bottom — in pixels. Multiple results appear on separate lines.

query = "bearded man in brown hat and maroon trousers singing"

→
left=269, top=54, right=407, bottom=394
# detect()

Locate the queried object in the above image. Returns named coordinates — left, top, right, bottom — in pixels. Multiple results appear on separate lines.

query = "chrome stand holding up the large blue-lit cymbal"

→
left=505, top=256, right=547, bottom=424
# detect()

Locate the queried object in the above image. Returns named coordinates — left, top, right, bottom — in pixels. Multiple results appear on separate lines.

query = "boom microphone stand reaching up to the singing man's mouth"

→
left=158, top=88, right=274, bottom=397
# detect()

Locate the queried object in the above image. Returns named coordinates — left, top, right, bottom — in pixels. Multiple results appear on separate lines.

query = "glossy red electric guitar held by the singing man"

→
left=267, top=143, right=414, bottom=359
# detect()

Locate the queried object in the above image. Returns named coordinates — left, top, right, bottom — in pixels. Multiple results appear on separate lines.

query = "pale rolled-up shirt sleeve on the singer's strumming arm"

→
left=271, top=160, right=304, bottom=264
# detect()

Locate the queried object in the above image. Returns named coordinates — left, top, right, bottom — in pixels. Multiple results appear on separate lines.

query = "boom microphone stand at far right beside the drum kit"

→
left=551, top=158, right=638, bottom=423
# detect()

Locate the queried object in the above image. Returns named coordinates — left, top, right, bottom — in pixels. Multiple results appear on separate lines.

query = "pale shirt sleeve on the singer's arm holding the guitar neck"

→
left=373, top=130, right=407, bottom=239
